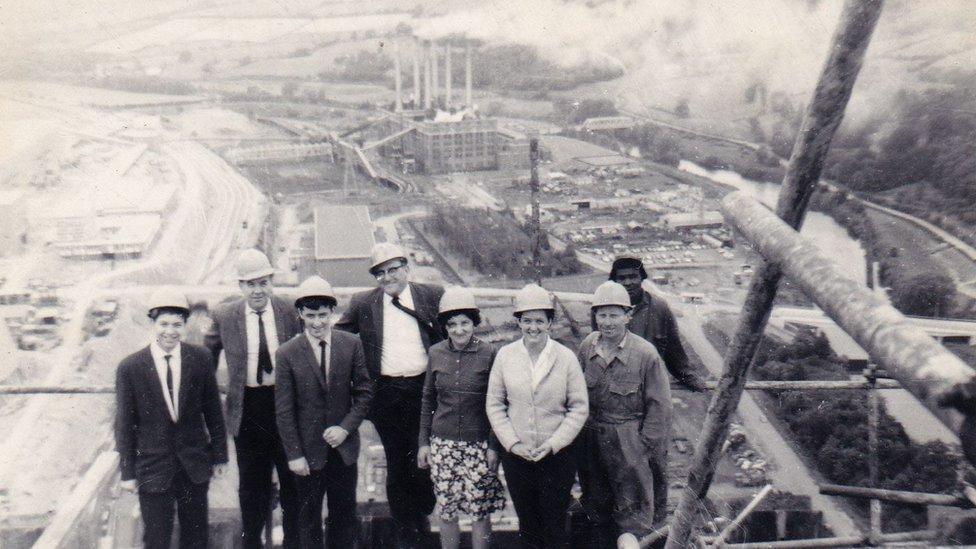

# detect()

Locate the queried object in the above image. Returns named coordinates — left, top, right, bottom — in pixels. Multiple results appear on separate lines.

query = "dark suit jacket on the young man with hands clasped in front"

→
left=275, top=330, right=373, bottom=470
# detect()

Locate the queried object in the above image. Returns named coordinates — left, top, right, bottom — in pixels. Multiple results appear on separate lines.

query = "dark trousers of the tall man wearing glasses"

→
left=370, top=375, right=434, bottom=533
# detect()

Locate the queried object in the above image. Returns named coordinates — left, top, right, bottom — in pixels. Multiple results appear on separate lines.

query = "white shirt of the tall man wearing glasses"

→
left=380, top=286, right=427, bottom=377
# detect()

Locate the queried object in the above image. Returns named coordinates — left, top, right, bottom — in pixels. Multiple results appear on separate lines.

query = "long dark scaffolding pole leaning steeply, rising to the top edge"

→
left=666, top=0, right=883, bottom=549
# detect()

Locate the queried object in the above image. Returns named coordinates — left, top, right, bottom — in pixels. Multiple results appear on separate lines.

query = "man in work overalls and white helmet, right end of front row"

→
left=579, top=281, right=671, bottom=547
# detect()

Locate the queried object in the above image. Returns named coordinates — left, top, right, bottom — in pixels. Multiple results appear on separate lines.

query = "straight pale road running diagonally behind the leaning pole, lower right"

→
left=669, top=298, right=860, bottom=536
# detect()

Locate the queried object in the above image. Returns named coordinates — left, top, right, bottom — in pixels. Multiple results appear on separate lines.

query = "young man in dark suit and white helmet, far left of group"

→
left=115, top=290, right=227, bottom=549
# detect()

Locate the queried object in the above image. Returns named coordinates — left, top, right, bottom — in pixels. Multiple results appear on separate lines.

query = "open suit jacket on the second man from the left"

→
left=204, top=295, right=302, bottom=437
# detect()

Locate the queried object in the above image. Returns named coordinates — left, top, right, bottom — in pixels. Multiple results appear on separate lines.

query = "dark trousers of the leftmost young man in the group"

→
left=139, top=469, right=210, bottom=549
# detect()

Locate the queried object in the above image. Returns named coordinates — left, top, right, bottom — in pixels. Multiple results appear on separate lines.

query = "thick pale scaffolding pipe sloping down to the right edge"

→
left=722, top=192, right=976, bottom=452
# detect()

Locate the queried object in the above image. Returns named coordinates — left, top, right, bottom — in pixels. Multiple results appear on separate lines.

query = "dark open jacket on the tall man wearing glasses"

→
left=335, top=282, right=444, bottom=379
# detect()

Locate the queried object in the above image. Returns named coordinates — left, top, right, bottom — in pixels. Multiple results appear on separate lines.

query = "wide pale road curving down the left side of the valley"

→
left=0, top=141, right=263, bottom=516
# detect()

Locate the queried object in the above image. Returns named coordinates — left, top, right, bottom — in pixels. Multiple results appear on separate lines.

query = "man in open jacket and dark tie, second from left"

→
left=205, top=250, right=301, bottom=549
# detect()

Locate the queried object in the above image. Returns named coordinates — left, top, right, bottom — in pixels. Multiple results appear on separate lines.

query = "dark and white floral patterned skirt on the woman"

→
left=430, top=437, right=505, bottom=520
